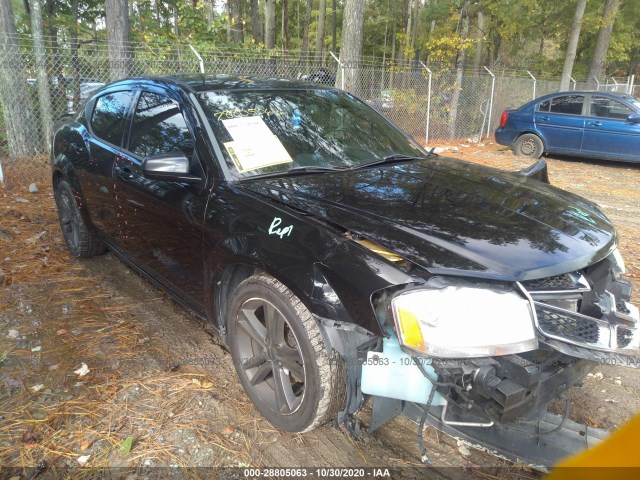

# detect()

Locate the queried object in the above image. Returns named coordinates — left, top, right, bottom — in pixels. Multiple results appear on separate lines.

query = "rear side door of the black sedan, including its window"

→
left=83, top=90, right=134, bottom=239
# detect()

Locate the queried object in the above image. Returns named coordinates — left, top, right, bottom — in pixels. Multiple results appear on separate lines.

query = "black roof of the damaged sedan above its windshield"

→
left=104, top=74, right=333, bottom=92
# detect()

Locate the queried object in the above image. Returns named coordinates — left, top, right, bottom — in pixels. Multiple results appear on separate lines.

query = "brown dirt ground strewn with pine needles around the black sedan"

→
left=0, top=144, right=640, bottom=478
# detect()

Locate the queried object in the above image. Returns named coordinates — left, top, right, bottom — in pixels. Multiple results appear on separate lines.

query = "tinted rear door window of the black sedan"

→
left=91, top=91, right=133, bottom=146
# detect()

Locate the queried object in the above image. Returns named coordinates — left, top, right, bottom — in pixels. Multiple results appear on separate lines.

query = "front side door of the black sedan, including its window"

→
left=114, top=92, right=207, bottom=309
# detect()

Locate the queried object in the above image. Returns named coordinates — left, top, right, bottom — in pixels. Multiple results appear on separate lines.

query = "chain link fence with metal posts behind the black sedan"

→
left=0, top=36, right=634, bottom=183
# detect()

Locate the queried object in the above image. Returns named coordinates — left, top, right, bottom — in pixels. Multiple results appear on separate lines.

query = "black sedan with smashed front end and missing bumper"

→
left=51, top=76, right=640, bottom=465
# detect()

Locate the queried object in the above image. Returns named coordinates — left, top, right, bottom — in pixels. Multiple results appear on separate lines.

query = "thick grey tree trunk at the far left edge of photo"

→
left=0, top=1, right=41, bottom=157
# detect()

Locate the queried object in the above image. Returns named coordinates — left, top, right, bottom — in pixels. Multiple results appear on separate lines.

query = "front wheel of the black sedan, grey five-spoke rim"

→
left=228, top=273, right=346, bottom=432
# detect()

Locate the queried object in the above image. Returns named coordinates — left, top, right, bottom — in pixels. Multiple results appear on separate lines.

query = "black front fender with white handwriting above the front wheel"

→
left=204, top=185, right=415, bottom=335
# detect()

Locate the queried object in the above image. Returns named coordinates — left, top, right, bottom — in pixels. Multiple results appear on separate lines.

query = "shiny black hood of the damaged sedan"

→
left=242, top=157, right=616, bottom=281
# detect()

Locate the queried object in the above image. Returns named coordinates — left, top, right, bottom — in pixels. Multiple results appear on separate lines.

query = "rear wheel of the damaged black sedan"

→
left=55, top=180, right=105, bottom=258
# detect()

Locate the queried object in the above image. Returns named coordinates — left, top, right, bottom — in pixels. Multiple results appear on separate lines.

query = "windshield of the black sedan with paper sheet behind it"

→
left=198, top=90, right=426, bottom=178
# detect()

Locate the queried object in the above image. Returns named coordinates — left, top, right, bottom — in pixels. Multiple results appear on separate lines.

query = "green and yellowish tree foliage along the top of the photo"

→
left=12, top=0, right=640, bottom=77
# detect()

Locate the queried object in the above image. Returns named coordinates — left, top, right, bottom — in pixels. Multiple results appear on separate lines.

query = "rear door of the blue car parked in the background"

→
left=534, top=95, right=585, bottom=154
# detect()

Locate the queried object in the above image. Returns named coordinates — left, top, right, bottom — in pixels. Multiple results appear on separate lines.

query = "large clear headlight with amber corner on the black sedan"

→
left=391, top=279, right=538, bottom=358
